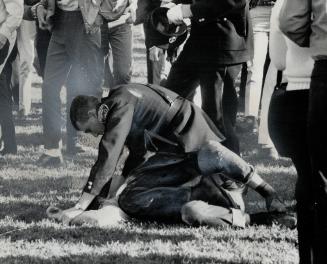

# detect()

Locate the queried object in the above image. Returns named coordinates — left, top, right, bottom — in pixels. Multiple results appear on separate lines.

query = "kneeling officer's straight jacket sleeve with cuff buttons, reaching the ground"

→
left=78, top=103, right=134, bottom=210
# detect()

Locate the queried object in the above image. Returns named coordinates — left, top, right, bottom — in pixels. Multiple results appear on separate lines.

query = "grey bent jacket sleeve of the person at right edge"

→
left=279, top=0, right=311, bottom=47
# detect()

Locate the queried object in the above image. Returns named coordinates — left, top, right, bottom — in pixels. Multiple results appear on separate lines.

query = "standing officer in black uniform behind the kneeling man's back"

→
left=165, top=0, right=253, bottom=154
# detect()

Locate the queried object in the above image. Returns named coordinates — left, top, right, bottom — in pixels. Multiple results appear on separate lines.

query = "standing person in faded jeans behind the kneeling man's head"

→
left=36, top=0, right=103, bottom=166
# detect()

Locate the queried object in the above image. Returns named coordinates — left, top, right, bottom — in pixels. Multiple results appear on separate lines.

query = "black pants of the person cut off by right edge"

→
left=308, top=60, right=327, bottom=263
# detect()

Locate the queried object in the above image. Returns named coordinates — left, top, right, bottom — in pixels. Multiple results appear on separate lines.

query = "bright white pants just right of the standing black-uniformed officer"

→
left=244, top=31, right=269, bottom=118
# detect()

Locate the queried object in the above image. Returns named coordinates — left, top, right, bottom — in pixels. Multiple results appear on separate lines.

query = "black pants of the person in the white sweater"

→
left=268, top=87, right=314, bottom=264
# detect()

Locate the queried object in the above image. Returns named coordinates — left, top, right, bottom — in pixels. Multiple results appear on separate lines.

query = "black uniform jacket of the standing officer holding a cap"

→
left=177, top=0, right=253, bottom=65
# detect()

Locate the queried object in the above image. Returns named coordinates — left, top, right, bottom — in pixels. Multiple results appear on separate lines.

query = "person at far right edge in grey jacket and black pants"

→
left=279, top=0, right=327, bottom=263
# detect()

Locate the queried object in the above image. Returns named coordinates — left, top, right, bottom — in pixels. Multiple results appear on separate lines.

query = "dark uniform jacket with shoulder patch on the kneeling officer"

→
left=83, top=84, right=224, bottom=207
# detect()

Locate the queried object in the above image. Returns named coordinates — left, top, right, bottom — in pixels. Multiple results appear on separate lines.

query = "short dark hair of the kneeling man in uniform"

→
left=70, top=95, right=99, bottom=130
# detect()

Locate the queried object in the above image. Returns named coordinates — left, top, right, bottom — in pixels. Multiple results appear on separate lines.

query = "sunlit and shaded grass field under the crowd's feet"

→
left=0, top=25, right=298, bottom=264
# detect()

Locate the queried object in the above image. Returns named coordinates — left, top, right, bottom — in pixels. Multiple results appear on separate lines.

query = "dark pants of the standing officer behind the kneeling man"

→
left=166, top=52, right=242, bottom=154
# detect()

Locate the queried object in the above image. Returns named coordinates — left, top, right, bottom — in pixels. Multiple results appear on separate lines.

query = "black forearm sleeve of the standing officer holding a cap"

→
left=191, top=0, right=246, bottom=19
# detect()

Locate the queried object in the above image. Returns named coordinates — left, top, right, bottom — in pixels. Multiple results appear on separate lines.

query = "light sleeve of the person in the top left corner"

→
left=0, top=0, right=24, bottom=39
